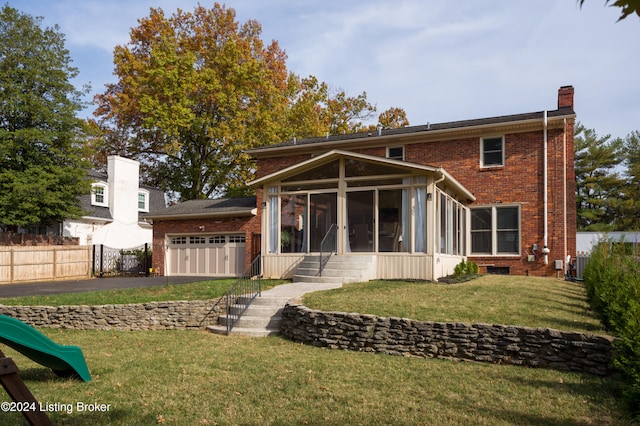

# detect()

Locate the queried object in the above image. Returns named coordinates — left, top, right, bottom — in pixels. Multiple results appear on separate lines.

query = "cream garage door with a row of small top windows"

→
left=167, top=234, right=246, bottom=277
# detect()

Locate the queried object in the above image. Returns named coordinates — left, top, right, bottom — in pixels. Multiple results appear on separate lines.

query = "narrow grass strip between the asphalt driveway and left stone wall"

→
left=0, top=278, right=288, bottom=306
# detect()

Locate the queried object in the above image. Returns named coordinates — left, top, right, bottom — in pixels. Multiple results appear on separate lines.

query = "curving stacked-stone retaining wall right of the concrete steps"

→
left=281, top=304, right=613, bottom=375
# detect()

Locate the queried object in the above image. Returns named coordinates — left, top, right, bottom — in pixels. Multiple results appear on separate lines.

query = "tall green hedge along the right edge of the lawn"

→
left=584, top=241, right=640, bottom=420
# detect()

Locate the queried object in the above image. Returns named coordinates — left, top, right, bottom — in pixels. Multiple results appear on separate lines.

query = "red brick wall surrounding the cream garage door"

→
left=153, top=216, right=260, bottom=275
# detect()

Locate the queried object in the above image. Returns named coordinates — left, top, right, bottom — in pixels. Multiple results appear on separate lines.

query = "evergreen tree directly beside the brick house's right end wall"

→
left=575, top=123, right=624, bottom=231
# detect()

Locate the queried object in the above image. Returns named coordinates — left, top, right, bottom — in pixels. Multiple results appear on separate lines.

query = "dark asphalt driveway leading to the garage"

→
left=0, top=277, right=214, bottom=298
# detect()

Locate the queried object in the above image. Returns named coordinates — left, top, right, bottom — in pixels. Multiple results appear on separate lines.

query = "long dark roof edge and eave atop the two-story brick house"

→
left=246, top=107, right=575, bottom=157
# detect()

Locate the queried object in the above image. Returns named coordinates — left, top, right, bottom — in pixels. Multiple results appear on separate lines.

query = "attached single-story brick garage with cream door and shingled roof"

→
left=145, top=197, right=260, bottom=277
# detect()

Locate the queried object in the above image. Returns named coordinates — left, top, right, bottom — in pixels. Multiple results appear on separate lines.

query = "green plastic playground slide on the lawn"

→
left=0, top=315, right=91, bottom=382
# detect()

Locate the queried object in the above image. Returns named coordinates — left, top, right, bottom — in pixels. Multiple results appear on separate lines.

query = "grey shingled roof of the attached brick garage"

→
left=143, top=197, right=258, bottom=220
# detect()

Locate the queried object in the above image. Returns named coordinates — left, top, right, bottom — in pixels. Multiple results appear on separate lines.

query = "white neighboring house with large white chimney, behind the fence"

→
left=62, top=155, right=165, bottom=249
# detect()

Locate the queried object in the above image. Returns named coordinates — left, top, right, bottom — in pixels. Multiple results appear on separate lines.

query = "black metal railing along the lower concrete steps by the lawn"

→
left=200, top=255, right=262, bottom=335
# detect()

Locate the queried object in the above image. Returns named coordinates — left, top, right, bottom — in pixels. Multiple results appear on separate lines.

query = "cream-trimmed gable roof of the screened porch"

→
left=249, top=149, right=476, bottom=201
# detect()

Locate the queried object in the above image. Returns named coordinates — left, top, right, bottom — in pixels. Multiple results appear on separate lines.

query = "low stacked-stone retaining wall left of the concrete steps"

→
left=0, top=299, right=226, bottom=330
